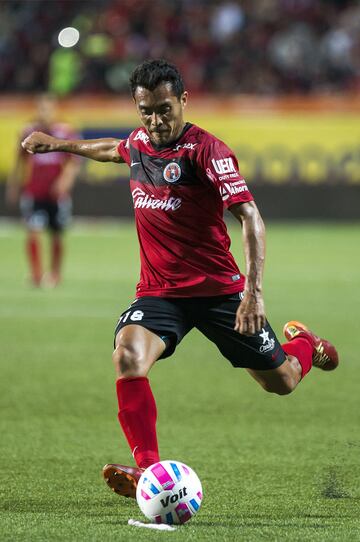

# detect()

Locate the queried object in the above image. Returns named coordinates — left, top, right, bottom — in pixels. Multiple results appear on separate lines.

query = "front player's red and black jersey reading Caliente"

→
left=118, top=123, right=253, bottom=297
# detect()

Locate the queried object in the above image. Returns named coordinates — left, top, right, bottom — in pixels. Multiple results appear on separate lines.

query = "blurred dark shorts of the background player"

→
left=20, top=195, right=71, bottom=232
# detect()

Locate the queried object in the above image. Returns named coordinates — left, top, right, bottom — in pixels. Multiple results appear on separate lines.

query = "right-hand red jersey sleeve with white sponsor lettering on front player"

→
left=198, top=139, right=254, bottom=209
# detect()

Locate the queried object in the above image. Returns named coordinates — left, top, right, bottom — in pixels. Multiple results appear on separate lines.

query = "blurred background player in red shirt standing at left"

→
left=6, top=94, right=79, bottom=286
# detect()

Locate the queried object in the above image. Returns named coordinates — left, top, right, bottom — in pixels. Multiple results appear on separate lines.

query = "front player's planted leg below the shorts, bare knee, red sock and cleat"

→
left=103, top=324, right=166, bottom=498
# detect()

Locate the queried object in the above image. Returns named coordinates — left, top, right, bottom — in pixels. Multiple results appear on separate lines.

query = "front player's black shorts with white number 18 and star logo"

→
left=115, top=293, right=286, bottom=370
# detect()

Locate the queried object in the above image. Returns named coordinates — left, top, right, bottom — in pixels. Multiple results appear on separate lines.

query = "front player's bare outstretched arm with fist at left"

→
left=22, top=132, right=124, bottom=163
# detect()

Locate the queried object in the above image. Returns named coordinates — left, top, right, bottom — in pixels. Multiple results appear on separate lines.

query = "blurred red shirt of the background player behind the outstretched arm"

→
left=22, top=124, right=76, bottom=201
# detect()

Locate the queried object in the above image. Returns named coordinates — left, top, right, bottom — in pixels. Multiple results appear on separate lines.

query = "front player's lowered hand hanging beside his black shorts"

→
left=235, top=290, right=266, bottom=335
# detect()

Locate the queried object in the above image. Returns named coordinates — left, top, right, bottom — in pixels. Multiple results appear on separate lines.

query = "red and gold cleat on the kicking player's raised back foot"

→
left=283, top=320, right=339, bottom=371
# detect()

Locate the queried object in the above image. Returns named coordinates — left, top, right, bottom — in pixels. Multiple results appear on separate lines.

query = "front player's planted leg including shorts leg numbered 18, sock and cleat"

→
left=103, top=297, right=191, bottom=497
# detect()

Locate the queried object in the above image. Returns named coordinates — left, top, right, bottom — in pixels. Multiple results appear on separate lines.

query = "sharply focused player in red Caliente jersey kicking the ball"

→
left=23, top=60, right=338, bottom=497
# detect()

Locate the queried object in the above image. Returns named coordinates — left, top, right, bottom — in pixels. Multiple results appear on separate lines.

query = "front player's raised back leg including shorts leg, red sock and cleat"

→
left=196, top=295, right=338, bottom=395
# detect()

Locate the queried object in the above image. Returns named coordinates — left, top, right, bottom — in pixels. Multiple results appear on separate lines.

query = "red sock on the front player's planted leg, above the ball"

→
left=116, top=377, right=160, bottom=469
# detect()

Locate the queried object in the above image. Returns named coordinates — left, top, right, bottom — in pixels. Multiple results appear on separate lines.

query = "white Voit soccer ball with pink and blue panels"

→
left=136, top=461, right=203, bottom=525
